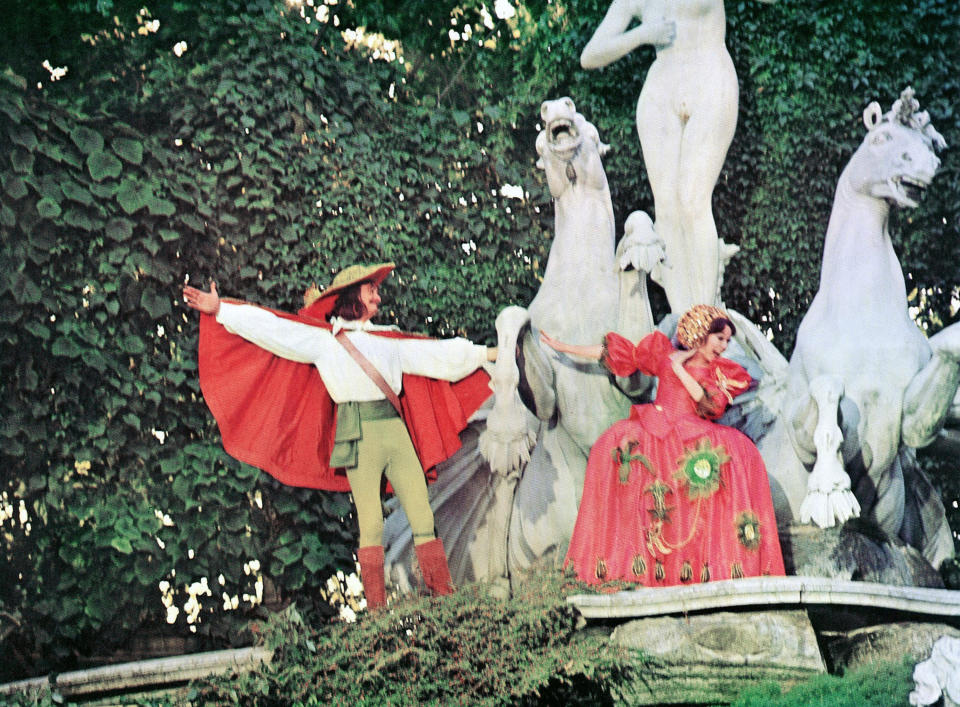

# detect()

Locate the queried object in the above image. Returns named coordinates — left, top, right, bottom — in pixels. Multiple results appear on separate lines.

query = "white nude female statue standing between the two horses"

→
left=580, top=0, right=774, bottom=313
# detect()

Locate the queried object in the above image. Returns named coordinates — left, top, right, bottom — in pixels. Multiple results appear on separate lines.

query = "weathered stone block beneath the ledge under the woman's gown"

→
left=610, top=610, right=826, bottom=704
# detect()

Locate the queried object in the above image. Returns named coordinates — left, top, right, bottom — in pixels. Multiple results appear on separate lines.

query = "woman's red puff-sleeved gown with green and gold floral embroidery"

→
left=564, top=332, right=784, bottom=586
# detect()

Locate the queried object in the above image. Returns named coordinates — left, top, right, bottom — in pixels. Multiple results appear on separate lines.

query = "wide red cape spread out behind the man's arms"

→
left=199, top=310, right=491, bottom=491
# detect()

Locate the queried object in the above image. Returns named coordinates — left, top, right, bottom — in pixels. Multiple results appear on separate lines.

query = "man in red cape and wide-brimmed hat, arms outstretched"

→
left=184, top=263, right=496, bottom=609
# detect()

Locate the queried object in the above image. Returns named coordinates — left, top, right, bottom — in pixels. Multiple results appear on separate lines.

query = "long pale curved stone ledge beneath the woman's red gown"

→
left=567, top=577, right=960, bottom=619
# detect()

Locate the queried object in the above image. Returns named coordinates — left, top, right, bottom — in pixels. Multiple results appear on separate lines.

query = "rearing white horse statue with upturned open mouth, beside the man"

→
left=385, top=98, right=663, bottom=591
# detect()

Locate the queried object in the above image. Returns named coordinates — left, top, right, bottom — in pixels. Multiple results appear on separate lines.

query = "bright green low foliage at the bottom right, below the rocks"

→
left=733, top=659, right=914, bottom=707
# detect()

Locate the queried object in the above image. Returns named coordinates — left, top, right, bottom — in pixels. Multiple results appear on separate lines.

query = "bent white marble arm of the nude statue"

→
left=580, top=0, right=677, bottom=69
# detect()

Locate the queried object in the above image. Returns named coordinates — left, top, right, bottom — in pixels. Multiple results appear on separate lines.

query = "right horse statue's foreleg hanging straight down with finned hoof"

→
left=800, top=375, right=860, bottom=528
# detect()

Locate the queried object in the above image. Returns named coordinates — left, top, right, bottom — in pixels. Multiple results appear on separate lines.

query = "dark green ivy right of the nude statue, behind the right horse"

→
left=728, top=0, right=960, bottom=352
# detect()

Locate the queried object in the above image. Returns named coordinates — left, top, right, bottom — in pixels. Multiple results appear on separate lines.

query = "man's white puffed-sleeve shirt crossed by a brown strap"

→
left=217, top=302, right=487, bottom=403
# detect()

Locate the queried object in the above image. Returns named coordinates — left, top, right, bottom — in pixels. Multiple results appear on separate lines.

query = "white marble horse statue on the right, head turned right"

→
left=738, top=88, right=960, bottom=567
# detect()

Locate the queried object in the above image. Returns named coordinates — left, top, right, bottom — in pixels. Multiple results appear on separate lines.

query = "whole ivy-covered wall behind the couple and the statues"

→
left=0, top=0, right=960, bottom=679
